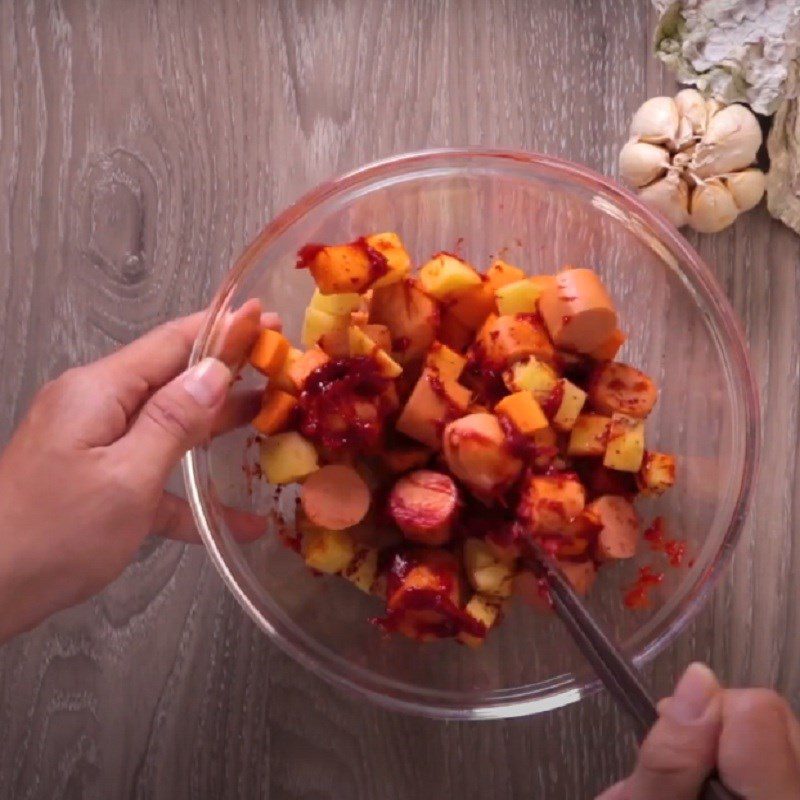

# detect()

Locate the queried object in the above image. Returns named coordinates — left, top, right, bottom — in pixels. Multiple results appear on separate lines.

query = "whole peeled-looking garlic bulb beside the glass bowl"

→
left=619, top=89, right=764, bottom=233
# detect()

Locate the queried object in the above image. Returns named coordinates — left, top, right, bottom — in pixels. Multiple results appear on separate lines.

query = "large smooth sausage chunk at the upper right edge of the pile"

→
left=539, top=269, right=617, bottom=353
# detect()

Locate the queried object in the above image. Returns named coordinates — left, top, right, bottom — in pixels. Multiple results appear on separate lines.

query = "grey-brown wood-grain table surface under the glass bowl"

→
left=0, top=0, right=800, bottom=800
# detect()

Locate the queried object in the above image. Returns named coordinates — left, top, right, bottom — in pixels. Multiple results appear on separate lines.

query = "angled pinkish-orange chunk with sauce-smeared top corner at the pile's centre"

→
left=395, top=370, right=471, bottom=450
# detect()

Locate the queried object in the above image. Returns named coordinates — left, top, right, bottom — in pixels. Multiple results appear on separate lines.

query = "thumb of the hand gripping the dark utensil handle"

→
left=625, top=664, right=722, bottom=800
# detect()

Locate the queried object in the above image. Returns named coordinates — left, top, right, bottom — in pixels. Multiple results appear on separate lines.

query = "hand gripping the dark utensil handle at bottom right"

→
left=597, top=664, right=800, bottom=800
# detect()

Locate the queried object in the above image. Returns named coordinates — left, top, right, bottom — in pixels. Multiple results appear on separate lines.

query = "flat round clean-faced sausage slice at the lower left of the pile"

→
left=300, top=464, right=370, bottom=531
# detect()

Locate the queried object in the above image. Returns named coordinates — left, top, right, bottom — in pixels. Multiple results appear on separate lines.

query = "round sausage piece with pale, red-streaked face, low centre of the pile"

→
left=389, top=469, right=458, bottom=545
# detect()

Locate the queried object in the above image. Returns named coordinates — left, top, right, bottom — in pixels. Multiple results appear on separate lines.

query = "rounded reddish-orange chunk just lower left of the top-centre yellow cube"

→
left=370, top=278, right=439, bottom=365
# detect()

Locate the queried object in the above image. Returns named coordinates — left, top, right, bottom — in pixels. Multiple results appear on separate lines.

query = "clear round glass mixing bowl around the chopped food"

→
left=184, top=148, right=758, bottom=719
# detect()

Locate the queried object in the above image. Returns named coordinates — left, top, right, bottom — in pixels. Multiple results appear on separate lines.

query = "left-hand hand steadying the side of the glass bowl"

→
left=0, top=301, right=279, bottom=641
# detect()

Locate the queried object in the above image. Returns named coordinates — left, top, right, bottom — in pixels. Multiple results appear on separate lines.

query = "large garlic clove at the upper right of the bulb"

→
left=690, top=104, right=762, bottom=178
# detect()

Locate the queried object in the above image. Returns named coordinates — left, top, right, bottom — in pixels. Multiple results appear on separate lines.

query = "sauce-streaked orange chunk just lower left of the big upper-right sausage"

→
left=475, top=314, right=555, bottom=369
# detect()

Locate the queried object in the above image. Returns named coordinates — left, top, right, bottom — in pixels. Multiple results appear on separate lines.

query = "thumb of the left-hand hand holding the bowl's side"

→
left=118, top=358, right=231, bottom=481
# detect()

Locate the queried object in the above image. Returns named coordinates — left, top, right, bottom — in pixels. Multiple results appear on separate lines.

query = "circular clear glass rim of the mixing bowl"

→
left=182, top=146, right=760, bottom=720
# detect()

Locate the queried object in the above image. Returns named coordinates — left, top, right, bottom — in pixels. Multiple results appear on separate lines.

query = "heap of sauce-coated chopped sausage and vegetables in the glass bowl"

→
left=244, top=233, right=675, bottom=646
